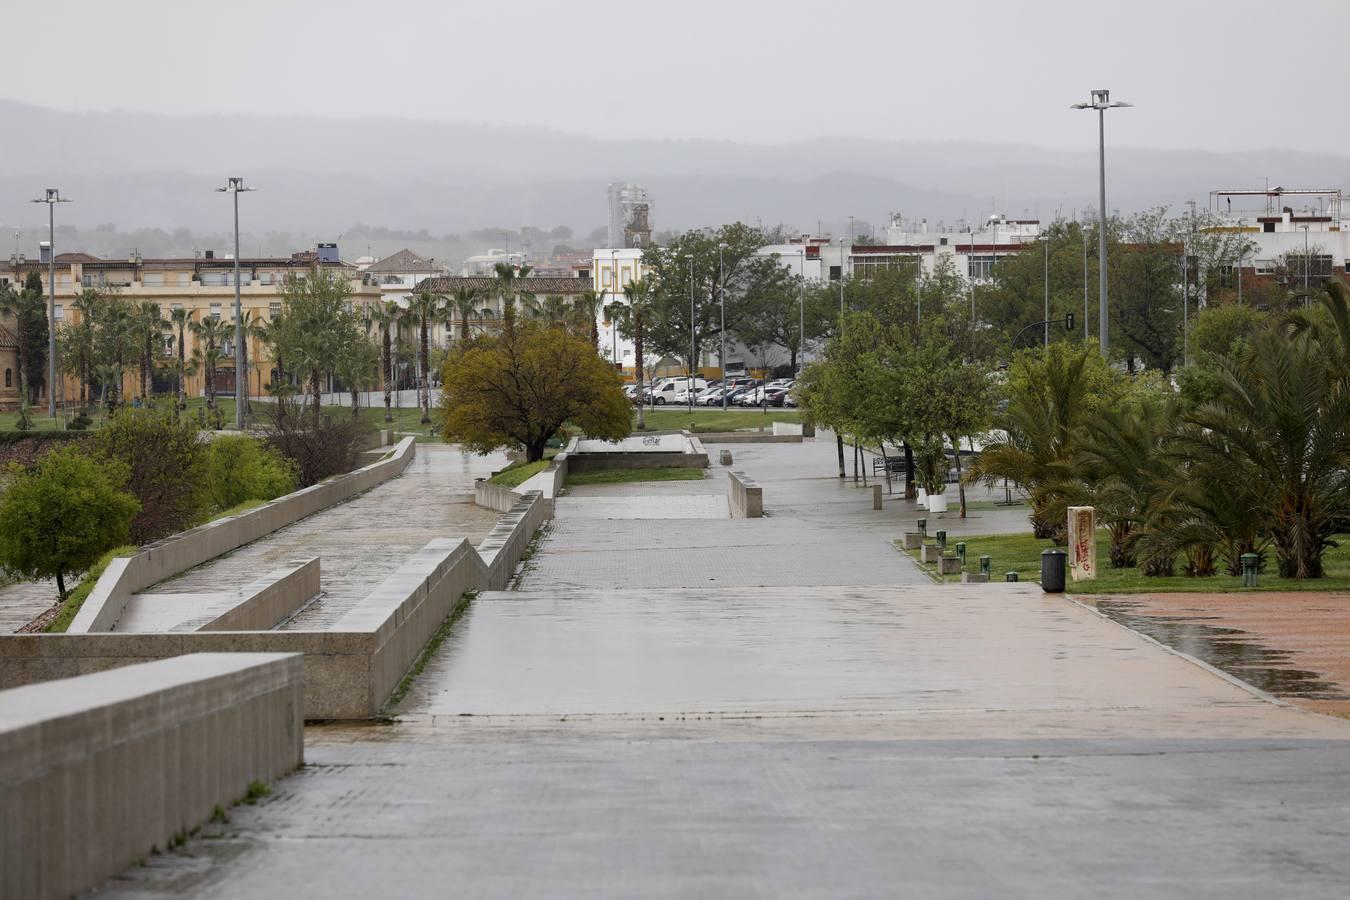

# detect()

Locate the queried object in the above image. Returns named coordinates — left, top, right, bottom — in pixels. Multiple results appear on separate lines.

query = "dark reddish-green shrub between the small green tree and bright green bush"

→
left=89, top=407, right=211, bottom=544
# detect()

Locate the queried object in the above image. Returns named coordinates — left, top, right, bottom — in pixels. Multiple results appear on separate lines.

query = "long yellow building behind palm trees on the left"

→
left=0, top=244, right=381, bottom=407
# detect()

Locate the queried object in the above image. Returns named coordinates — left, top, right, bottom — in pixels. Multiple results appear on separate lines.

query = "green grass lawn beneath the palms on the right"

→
left=909, top=529, right=1350, bottom=594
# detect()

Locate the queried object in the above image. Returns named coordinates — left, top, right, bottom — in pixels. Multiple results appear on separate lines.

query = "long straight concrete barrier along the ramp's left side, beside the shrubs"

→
left=69, top=437, right=417, bottom=633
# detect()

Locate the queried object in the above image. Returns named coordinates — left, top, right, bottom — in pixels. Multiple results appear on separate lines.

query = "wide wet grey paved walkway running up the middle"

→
left=104, top=431, right=1350, bottom=900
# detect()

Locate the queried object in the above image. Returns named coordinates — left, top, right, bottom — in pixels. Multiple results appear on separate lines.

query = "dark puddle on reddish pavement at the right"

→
left=1094, top=600, right=1350, bottom=700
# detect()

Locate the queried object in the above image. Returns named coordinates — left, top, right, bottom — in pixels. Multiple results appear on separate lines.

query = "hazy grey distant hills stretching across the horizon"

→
left=0, top=101, right=1350, bottom=236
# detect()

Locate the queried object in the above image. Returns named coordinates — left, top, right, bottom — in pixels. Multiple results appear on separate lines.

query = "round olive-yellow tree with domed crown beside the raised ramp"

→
left=441, top=321, right=630, bottom=461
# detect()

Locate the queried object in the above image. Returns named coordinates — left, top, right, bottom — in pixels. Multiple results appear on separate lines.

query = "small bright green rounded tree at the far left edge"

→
left=0, top=447, right=139, bottom=600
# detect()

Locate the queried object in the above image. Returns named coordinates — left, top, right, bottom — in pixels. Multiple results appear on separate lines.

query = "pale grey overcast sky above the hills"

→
left=0, top=0, right=1350, bottom=152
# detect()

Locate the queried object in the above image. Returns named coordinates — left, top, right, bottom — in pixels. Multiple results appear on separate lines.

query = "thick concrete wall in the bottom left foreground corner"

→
left=0, top=653, right=304, bottom=899
